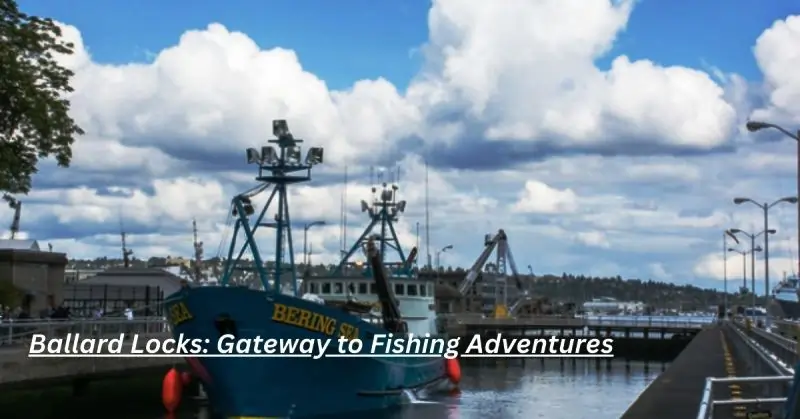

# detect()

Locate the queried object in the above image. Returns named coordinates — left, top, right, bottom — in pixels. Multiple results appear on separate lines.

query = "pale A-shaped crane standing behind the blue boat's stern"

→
left=459, top=229, right=523, bottom=318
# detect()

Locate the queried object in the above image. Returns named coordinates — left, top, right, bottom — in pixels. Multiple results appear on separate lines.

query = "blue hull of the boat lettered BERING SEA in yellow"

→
left=166, top=287, right=446, bottom=418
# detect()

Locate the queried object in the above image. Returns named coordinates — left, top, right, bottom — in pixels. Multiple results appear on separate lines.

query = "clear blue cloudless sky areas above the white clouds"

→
left=20, top=0, right=800, bottom=89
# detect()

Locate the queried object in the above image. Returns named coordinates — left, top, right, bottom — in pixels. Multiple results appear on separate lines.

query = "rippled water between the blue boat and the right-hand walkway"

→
left=186, top=359, right=666, bottom=419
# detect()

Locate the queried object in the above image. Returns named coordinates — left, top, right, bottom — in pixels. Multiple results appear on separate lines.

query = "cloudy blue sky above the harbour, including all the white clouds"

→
left=9, top=0, right=800, bottom=287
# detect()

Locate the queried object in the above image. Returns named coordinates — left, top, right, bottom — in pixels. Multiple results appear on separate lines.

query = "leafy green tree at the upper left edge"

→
left=0, top=0, right=83, bottom=203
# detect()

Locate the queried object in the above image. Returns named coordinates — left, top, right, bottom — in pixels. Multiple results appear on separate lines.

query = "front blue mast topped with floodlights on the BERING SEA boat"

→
left=221, top=120, right=323, bottom=295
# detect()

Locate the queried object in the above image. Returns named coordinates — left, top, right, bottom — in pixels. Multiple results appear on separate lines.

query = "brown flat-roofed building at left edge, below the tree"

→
left=0, top=239, right=67, bottom=315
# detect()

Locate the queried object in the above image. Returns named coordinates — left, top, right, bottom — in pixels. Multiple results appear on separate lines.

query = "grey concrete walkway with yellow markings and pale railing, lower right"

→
left=622, top=320, right=798, bottom=419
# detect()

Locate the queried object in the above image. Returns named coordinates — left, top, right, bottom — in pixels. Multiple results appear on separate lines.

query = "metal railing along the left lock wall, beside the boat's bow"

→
left=0, top=317, right=169, bottom=349
